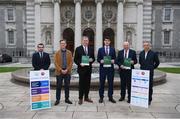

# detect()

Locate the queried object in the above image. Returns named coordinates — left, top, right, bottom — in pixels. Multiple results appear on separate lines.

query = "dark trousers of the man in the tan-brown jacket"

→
left=56, top=74, right=71, bottom=100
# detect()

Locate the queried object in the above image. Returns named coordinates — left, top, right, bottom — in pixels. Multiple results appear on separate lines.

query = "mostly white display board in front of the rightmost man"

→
left=131, top=69, right=150, bottom=108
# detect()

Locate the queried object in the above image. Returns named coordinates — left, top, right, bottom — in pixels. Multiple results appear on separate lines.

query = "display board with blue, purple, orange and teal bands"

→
left=30, top=70, right=51, bottom=110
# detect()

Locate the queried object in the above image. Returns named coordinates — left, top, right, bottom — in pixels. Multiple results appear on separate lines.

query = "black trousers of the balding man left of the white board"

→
left=120, top=69, right=131, bottom=100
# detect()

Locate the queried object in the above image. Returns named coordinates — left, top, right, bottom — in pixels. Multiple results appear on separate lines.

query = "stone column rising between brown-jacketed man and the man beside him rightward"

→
left=74, top=0, right=82, bottom=48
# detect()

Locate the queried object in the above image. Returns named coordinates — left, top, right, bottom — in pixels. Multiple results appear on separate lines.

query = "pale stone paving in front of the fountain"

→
left=0, top=73, right=180, bottom=119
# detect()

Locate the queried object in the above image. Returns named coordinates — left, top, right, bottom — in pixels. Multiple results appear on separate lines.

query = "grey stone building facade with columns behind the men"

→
left=0, top=0, right=180, bottom=61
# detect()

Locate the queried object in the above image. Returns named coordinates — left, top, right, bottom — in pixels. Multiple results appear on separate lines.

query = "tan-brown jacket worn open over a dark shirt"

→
left=54, top=49, right=73, bottom=75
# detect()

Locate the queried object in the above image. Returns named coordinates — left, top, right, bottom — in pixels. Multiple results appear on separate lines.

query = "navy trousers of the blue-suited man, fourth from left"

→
left=99, top=68, right=114, bottom=98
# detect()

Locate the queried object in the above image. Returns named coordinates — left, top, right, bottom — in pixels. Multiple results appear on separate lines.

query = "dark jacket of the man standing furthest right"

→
left=139, top=50, right=160, bottom=71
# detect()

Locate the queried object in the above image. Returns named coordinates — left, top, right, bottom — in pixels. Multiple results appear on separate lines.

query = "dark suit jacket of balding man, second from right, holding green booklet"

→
left=116, top=49, right=137, bottom=69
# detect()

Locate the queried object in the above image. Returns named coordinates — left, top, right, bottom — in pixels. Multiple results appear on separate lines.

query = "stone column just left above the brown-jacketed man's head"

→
left=53, top=0, right=61, bottom=52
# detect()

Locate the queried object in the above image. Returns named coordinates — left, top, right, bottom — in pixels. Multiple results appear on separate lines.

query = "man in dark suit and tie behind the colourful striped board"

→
left=32, top=43, right=51, bottom=70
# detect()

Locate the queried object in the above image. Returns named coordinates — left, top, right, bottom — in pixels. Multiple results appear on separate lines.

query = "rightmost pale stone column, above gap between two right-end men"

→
left=136, top=1, right=143, bottom=51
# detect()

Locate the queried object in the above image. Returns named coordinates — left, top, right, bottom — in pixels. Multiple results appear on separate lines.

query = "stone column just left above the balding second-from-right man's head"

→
left=115, top=0, right=124, bottom=50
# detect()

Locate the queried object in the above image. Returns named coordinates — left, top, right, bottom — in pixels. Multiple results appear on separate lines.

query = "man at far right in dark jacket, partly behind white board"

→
left=139, top=41, right=160, bottom=105
